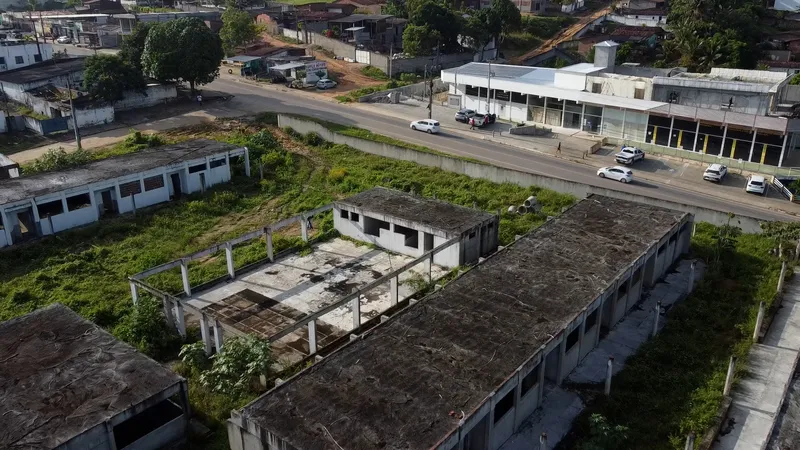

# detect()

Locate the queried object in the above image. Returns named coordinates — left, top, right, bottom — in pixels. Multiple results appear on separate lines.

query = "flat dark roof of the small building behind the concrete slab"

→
left=335, top=187, right=494, bottom=233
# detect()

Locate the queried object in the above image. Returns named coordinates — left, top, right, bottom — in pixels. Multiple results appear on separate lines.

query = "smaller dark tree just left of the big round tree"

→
left=83, top=55, right=147, bottom=102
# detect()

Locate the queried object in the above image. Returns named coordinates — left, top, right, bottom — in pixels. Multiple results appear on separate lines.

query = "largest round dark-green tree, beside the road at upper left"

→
left=142, top=17, right=225, bottom=93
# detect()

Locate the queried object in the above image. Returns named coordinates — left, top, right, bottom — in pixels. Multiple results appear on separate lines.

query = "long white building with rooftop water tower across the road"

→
left=442, top=41, right=797, bottom=167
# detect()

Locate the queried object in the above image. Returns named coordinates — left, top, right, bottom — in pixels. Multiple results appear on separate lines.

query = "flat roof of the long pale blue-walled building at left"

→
left=0, top=139, right=239, bottom=205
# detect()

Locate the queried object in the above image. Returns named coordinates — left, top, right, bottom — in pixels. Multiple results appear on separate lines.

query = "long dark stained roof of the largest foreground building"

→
left=239, top=196, right=686, bottom=450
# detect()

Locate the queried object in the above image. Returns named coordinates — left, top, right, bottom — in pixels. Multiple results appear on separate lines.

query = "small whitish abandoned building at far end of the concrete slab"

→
left=333, top=187, right=499, bottom=267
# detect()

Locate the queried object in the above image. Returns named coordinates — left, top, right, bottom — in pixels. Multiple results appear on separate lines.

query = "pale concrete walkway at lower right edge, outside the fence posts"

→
left=711, top=277, right=800, bottom=450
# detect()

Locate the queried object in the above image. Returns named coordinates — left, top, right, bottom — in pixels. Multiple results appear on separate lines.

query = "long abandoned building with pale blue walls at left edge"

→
left=0, top=139, right=250, bottom=248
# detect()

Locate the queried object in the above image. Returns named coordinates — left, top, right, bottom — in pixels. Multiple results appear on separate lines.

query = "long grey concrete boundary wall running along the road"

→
left=278, top=114, right=762, bottom=233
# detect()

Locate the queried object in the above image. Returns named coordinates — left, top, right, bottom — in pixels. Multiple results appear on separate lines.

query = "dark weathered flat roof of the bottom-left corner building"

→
left=0, top=304, right=183, bottom=449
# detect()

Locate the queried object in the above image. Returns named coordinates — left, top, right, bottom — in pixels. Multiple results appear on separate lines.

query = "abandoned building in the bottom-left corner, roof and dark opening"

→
left=0, top=304, right=189, bottom=450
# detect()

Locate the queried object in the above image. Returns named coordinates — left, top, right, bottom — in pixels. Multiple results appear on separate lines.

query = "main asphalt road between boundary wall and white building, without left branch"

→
left=207, top=79, right=797, bottom=221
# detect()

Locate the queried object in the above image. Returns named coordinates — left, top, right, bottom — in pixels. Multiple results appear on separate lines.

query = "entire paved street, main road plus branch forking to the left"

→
left=14, top=74, right=797, bottom=220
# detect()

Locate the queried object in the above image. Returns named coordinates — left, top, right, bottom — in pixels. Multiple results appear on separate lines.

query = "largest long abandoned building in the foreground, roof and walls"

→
left=228, top=196, right=693, bottom=450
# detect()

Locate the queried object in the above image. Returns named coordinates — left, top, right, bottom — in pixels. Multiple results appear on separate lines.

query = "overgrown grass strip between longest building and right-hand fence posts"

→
left=560, top=224, right=780, bottom=450
